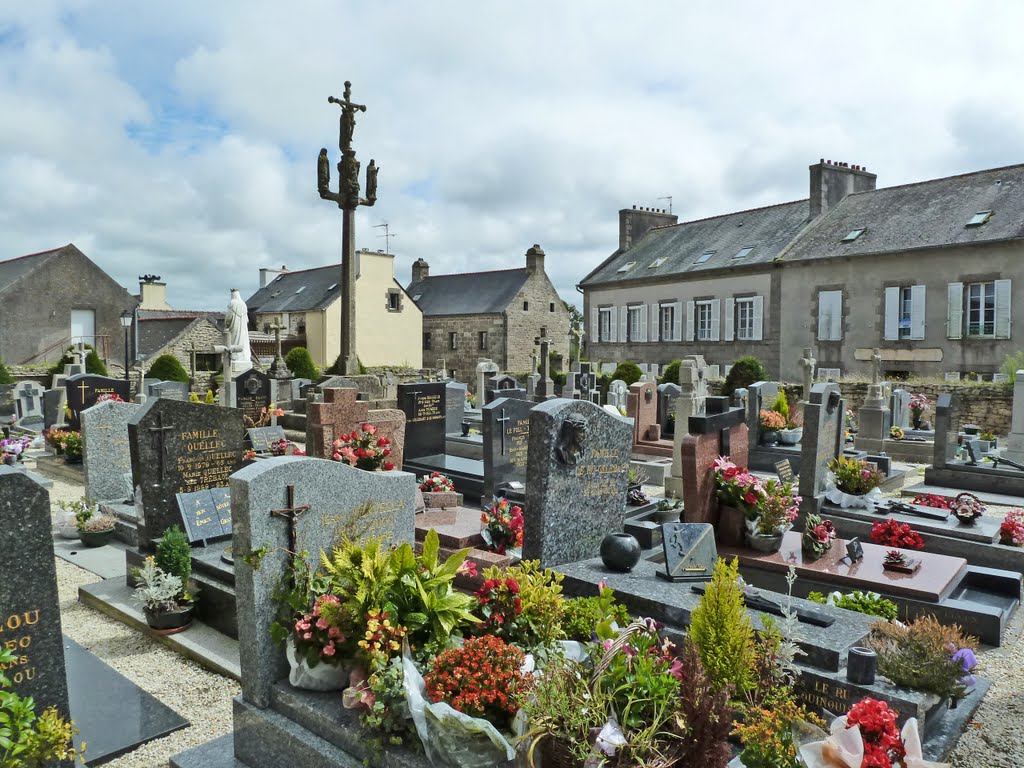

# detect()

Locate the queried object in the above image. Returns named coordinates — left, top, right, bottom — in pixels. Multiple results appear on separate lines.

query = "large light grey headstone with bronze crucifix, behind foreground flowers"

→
left=230, top=456, right=416, bottom=708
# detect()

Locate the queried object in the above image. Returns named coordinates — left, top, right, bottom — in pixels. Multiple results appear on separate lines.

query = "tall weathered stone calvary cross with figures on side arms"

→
left=316, top=80, right=380, bottom=376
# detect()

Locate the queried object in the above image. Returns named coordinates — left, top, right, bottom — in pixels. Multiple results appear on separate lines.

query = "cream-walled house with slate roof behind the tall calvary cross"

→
left=246, top=250, right=423, bottom=369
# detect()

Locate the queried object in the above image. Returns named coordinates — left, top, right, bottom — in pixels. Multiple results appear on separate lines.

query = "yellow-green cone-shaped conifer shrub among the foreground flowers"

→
left=689, top=558, right=755, bottom=700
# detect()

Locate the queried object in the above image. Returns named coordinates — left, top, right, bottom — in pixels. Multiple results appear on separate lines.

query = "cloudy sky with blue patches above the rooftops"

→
left=0, top=0, right=1024, bottom=308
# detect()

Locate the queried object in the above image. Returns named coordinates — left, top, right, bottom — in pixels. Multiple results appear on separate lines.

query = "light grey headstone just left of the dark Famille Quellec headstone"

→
left=81, top=400, right=140, bottom=502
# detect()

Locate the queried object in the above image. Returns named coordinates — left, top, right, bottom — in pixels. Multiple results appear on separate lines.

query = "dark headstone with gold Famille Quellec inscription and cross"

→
left=128, top=399, right=245, bottom=548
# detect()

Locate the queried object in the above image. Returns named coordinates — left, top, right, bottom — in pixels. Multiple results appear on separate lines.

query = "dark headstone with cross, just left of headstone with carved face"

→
left=480, top=397, right=535, bottom=499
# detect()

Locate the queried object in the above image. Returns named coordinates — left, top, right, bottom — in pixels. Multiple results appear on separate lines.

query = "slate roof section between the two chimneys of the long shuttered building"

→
left=580, top=200, right=809, bottom=286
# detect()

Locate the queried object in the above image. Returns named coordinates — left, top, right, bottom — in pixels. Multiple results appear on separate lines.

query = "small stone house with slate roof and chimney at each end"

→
left=406, top=245, right=569, bottom=381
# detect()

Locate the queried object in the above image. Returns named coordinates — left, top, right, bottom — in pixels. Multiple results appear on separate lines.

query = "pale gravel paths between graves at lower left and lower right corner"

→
left=39, top=473, right=1024, bottom=768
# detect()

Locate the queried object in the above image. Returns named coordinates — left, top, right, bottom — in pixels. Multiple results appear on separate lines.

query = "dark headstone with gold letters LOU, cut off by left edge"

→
left=0, top=466, right=71, bottom=729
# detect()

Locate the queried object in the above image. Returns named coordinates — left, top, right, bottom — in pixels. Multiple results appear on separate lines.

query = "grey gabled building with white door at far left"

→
left=0, top=243, right=135, bottom=365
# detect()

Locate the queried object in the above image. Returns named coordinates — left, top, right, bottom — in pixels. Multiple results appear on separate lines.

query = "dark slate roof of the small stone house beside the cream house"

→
left=406, top=267, right=529, bottom=316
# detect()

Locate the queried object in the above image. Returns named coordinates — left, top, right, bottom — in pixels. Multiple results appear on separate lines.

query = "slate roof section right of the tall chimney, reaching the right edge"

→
left=783, top=165, right=1024, bottom=261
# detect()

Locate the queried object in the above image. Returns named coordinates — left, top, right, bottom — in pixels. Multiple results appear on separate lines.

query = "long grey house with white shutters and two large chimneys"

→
left=580, top=161, right=1024, bottom=380
